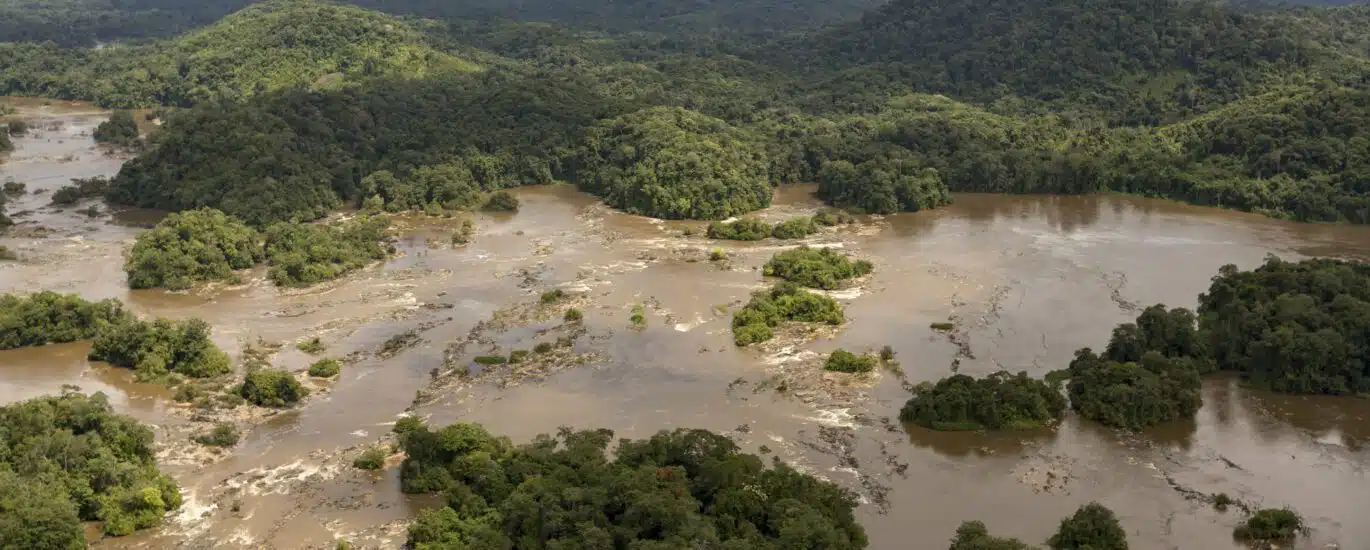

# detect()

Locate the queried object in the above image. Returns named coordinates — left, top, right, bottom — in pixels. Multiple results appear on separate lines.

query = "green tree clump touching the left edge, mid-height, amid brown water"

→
left=0, top=291, right=132, bottom=350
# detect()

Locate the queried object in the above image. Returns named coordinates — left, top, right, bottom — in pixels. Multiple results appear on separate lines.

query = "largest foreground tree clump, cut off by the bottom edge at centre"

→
left=400, top=424, right=867, bottom=550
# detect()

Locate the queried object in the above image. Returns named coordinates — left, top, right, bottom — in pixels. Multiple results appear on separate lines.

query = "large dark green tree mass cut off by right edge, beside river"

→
left=1199, top=258, right=1370, bottom=394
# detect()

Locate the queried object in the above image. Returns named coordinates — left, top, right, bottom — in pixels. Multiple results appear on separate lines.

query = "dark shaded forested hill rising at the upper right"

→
left=783, top=0, right=1367, bottom=123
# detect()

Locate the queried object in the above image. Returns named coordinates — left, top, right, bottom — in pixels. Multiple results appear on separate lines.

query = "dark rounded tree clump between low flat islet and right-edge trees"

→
left=1067, top=348, right=1203, bottom=429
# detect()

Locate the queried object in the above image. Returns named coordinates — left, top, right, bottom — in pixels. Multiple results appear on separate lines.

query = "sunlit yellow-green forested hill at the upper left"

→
left=0, top=0, right=480, bottom=107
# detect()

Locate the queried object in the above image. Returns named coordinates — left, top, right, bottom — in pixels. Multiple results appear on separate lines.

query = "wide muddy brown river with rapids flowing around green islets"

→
left=0, top=103, right=1370, bottom=549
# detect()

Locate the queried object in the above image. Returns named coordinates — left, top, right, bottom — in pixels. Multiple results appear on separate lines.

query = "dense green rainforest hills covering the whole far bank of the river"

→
left=0, top=0, right=1370, bottom=228
